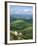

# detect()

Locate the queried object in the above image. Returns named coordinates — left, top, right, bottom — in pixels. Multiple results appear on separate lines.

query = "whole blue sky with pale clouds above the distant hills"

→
left=10, top=5, right=32, bottom=15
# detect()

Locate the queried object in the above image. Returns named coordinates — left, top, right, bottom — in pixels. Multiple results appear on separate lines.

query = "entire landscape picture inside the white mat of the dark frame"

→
left=10, top=6, right=33, bottom=40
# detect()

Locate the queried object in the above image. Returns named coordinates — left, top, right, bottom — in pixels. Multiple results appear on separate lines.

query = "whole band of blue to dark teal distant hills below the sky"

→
left=10, top=14, right=32, bottom=23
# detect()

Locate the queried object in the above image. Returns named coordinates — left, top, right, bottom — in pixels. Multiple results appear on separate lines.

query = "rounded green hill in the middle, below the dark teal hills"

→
left=11, top=20, right=31, bottom=30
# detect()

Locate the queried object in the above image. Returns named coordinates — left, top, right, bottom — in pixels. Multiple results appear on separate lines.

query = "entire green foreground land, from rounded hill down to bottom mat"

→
left=10, top=19, right=33, bottom=40
